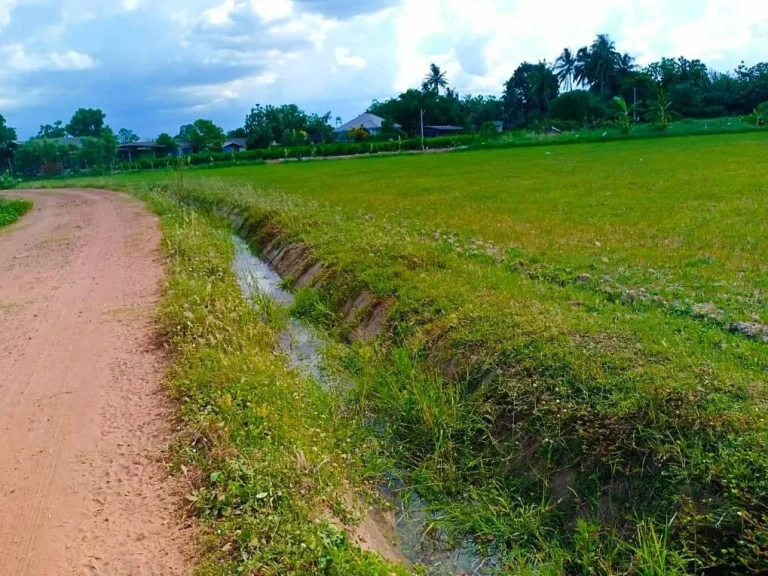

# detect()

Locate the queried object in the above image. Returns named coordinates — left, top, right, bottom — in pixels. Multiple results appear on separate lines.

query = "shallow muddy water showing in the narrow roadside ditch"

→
left=232, top=236, right=493, bottom=576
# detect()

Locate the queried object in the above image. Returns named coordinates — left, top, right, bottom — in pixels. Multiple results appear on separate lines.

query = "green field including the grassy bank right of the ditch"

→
left=39, top=134, right=768, bottom=574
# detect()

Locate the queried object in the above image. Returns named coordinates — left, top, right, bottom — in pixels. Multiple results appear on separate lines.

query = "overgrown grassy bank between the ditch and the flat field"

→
left=31, top=181, right=768, bottom=574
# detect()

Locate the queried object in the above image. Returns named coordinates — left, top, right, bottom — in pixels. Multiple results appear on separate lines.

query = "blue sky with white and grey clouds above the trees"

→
left=0, top=0, right=768, bottom=138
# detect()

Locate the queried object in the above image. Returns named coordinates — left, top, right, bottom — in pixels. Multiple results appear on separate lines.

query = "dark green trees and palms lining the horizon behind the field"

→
left=0, top=34, right=768, bottom=172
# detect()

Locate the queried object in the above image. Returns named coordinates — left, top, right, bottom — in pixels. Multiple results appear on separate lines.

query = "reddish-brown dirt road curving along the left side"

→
left=0, top=190, right=191, bottom=576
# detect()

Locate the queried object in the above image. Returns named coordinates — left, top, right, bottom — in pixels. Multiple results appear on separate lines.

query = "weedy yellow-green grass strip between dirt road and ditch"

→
left=139, top=194, right=407, bottom=576
